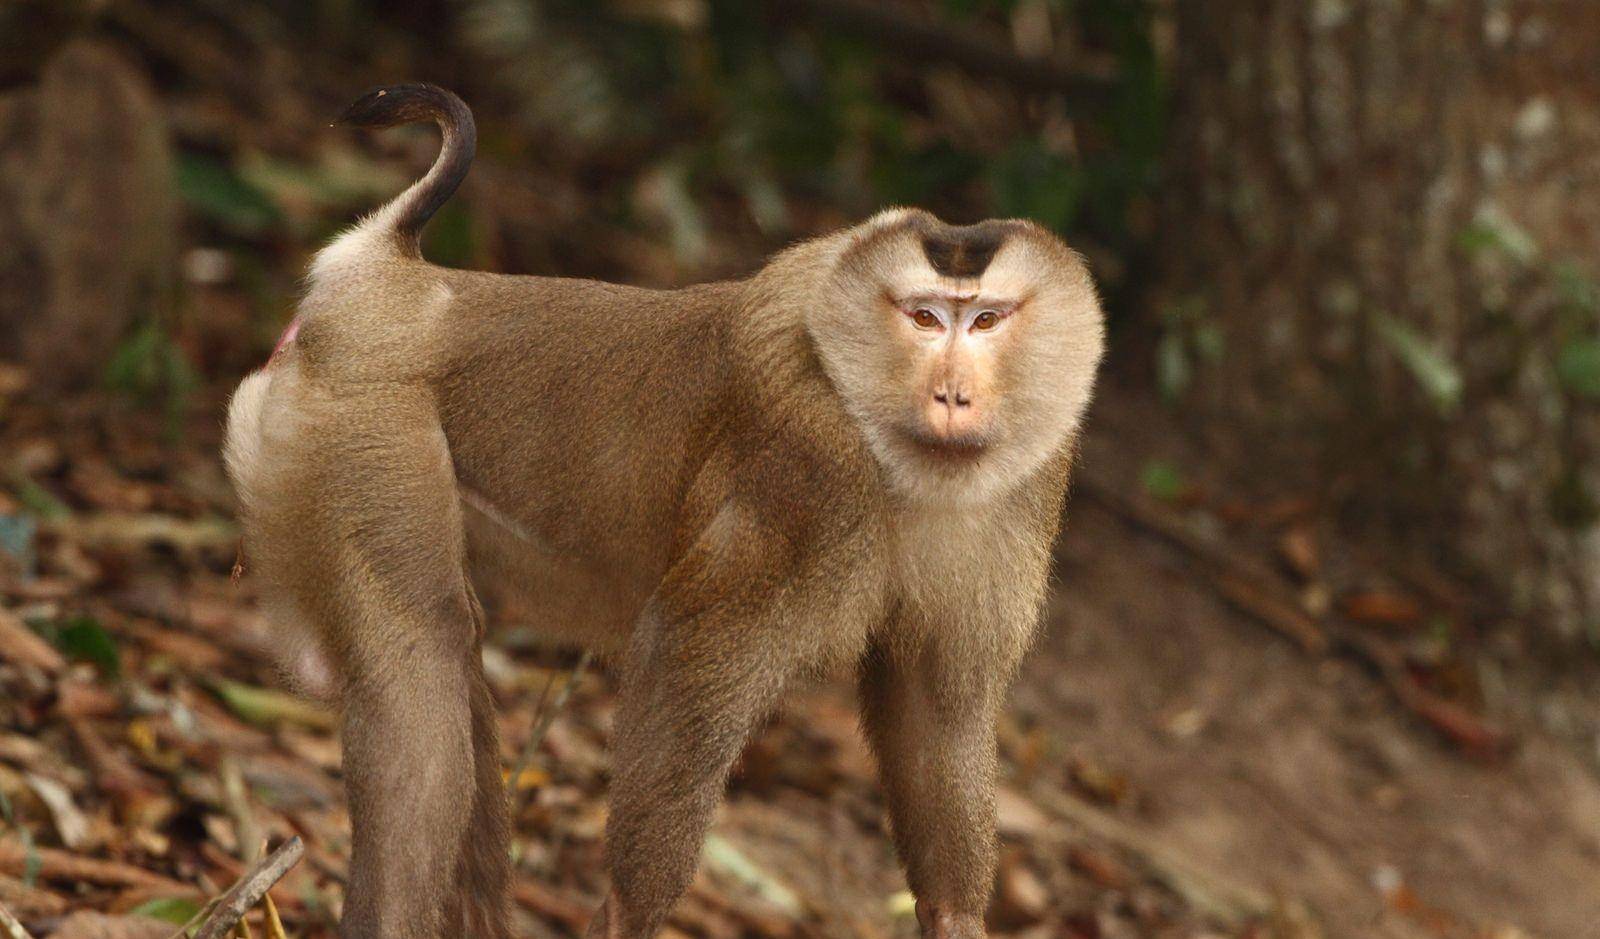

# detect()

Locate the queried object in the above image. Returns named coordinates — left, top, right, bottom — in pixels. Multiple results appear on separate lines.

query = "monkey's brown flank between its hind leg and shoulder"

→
left=434, top=272, right=739, bottom=632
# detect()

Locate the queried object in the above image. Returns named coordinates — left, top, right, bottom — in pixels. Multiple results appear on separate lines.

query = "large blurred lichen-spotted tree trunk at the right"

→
left=1163, top=0, right=1600, bottom=638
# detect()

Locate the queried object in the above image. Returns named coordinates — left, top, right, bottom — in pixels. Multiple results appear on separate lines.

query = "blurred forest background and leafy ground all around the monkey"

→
left=0, top=0, right=1600, bottom=939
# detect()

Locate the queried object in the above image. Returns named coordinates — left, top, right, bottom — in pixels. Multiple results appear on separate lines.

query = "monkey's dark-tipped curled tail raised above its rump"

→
left=338, top=83, right=478, bottom=256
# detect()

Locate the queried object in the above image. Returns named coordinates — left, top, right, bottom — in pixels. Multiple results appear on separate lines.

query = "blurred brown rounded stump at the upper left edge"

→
left=0, top=38, right=176, bottom=389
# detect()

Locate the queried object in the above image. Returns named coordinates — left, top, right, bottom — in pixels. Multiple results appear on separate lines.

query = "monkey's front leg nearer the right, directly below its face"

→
left=861, top=637, right=1011, bottom=939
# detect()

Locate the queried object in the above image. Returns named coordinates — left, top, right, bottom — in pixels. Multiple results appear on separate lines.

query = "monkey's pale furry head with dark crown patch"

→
left=806, top=210, right=1104, bottom=502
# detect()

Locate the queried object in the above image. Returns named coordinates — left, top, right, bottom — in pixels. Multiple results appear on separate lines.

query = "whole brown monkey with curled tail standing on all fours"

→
left=224, top=85, right=1104, bottom=939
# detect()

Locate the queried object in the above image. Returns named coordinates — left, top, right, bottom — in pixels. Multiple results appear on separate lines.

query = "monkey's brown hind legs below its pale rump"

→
left=258, top=386, right=509, bottom=939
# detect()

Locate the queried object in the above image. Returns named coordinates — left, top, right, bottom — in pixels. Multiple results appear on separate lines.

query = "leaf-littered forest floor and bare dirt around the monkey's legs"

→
left=0, top=373, right=1600, bottom=939
